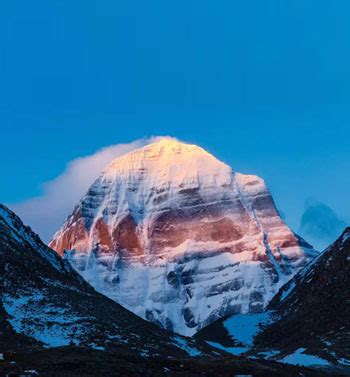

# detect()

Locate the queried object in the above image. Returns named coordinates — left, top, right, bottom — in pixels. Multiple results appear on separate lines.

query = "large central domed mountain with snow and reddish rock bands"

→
left=50, top=138, right=316, bottom=335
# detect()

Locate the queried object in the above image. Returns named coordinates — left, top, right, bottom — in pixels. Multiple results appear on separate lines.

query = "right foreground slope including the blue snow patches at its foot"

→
left=195, top=228, right=350, bottom=368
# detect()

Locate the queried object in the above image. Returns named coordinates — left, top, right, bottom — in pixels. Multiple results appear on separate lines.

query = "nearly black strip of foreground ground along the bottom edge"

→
left=0, top=347, right=327, bottom=377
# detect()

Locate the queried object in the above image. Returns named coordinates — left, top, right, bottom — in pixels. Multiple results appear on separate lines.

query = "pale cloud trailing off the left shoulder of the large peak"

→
left=9, top=137, right=158, bottom=242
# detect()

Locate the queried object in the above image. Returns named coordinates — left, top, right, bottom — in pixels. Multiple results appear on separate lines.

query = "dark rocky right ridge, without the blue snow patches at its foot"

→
left=255, top=228, right=350, bottom=367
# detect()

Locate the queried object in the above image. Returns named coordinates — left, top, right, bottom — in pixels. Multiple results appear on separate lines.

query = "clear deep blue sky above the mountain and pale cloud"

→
left=0, top=0, right=350, bottom=247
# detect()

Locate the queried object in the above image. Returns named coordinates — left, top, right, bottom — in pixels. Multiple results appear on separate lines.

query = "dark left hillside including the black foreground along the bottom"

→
left=0, top=204, right=318, bottom=377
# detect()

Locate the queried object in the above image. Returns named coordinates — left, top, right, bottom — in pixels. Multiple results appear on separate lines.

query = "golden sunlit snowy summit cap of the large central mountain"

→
left=102, top=138, right=233, bottom=191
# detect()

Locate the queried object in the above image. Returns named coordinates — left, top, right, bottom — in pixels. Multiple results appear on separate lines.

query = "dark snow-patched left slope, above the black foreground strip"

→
left=0, top=204, right=211, bottom=356
